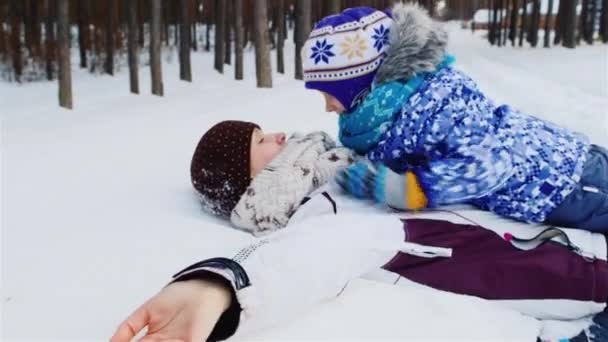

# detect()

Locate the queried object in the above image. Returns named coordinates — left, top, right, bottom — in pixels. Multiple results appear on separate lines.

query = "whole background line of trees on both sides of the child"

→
left=11, top=0, right=608, bottom=108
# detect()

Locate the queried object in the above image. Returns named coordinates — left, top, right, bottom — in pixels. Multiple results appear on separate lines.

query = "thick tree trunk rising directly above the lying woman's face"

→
left=253, top=0, right=272, bottom=88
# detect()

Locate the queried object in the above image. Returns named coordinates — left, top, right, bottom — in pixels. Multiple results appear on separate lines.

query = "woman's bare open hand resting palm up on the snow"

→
left=110, top=280, right=230, bottom=342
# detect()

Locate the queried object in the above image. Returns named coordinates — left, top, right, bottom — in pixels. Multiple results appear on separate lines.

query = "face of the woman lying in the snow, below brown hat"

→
left=251, top=129, right=285, bottom=178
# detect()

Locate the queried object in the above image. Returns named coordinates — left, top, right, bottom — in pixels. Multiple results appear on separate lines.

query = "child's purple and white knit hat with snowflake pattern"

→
left=302, top=7, right=393, bottom=111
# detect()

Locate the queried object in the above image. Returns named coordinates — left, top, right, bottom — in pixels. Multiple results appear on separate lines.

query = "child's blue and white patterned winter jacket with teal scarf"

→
left=339, top=6, right=589, bottom=222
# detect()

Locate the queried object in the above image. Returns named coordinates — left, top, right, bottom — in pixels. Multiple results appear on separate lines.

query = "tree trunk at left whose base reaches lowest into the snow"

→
left=57, top=0, right=72, bottom=109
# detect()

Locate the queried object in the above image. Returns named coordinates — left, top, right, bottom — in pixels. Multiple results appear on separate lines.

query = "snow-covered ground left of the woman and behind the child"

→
left=0, top=24, right=608, bottom=340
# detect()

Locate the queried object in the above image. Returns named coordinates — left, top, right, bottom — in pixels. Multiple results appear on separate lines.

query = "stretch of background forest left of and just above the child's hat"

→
left=0, top=0, right=444, bottom=108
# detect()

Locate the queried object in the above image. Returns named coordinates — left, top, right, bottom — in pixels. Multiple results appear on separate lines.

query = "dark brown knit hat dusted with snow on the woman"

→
left=190, top=121, right=260, bottom=218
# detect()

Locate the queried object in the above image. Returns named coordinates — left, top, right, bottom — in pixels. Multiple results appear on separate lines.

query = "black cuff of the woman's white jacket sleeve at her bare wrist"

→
left=171, top=258, right=250, bottom=341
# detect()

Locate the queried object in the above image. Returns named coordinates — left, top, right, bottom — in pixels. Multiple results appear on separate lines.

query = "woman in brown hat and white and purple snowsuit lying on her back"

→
left=112, top=121, right=608, bottom=342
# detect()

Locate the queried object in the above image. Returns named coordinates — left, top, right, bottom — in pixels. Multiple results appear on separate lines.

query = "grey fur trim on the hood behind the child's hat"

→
left=375, top=4, right=448, bottom=84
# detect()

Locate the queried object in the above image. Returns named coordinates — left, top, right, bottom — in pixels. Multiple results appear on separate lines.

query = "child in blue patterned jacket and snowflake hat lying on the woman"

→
left=302, top=4, right=608, bottom=232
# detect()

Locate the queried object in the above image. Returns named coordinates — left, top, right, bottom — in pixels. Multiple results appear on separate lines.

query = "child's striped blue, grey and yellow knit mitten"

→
left=336, top=160, right=428, bottom=210
